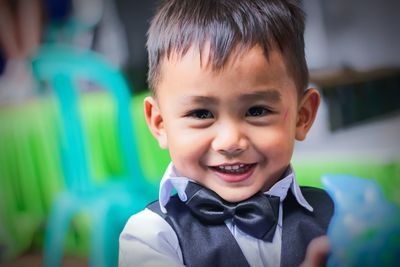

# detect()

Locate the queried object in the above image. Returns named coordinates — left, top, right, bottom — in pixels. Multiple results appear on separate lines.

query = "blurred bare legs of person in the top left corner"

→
left=0, top=0, right=42, bottom=103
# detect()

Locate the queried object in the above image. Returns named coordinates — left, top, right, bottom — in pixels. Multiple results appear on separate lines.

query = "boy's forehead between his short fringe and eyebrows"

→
left=156, top=46, right=296, bottom=100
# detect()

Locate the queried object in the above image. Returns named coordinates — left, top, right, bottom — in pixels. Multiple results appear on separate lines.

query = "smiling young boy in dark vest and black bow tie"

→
left=119, top=0, right=333, bottom=266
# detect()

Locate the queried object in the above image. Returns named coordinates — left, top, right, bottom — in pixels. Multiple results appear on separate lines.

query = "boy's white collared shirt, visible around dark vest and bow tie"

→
left=119, top=163, right=313, bottom=267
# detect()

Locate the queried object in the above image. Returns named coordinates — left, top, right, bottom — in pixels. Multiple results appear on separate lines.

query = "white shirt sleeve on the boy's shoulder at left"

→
left=118, top=209, right=184, bottom=267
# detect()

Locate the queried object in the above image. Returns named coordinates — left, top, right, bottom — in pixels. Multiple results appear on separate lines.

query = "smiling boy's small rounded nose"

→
left=212, top=122, right=248, bottom=157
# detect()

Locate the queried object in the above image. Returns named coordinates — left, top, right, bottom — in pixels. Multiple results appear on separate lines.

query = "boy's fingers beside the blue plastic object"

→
left=300, top=235, right=330, bottom=267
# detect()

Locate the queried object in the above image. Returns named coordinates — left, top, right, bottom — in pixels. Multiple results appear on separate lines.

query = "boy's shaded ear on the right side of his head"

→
left=296, top=88, right=321, bottom=141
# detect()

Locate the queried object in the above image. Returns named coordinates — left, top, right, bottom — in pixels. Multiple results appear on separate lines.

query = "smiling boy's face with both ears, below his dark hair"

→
left=145, top=46, right=319, bottom=202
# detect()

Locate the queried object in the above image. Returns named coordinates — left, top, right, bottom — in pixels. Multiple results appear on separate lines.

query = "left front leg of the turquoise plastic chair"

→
left=43, top=194, right=79, bottom=267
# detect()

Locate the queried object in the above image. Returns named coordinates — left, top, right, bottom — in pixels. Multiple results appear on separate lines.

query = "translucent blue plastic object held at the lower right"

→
left=321, top=175, right=400, bottom=267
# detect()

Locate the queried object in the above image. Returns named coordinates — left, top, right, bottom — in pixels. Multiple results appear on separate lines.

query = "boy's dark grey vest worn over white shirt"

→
left=147, top=187, right=334, bottom=267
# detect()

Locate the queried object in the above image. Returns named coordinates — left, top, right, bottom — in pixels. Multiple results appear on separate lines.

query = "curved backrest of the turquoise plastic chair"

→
left=32, top=45, right=144, bottom=194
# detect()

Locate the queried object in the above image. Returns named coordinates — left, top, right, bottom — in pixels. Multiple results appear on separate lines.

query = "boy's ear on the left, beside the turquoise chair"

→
left=143, top=96, right=168, bottom=148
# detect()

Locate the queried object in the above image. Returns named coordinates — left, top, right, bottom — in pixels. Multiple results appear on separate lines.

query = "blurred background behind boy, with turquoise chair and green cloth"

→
left=0, top=0, right=400, bottom=266
